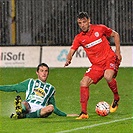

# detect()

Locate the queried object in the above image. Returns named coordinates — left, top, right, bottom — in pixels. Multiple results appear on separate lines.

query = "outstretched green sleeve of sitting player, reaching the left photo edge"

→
left=0, top=80, right=29, bottom=92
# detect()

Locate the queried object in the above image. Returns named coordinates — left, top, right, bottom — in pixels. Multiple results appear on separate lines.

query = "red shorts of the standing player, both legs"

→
left=84, top=56, right=120, bottom=84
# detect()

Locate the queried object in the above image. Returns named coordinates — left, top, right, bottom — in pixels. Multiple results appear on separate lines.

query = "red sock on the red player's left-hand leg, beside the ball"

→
left=80, top=86, right=89, bottom=114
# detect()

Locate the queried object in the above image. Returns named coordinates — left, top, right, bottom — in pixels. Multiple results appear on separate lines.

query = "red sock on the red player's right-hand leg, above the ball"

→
left=108, top=78, right=119, bottom=100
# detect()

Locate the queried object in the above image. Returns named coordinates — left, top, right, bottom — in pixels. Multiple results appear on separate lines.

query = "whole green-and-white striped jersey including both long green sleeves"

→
left=0, top=78, right=67, bottom=116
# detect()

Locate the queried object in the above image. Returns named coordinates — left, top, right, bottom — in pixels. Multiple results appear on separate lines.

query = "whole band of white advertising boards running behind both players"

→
left=0, top=46, right=133, bottom=68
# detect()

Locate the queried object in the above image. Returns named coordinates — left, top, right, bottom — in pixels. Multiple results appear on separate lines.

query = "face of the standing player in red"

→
left=77, top=18, right=90, bottom=32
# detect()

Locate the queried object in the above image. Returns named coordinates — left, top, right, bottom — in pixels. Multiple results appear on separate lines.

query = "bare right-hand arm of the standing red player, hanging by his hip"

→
left=111, top=30, right=122, bottom=61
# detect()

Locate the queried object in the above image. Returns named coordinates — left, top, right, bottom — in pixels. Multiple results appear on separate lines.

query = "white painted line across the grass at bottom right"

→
left=57, top=117, right=133, bottom=133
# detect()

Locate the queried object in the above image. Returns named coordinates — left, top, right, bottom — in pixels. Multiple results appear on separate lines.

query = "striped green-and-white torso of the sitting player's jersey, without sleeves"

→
left=26, top=79, right=55, bottom=106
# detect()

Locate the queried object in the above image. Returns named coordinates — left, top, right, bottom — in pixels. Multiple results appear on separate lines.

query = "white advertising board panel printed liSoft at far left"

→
left=0, top=46, right=40, bottom=67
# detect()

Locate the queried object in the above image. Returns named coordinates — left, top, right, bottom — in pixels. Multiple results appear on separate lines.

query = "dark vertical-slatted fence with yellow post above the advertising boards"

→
left=0, top=0, right=133, bottom=46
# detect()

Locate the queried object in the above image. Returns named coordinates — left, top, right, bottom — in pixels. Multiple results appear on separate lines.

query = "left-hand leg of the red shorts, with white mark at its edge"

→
left=84, top=65, right=104, bottom=84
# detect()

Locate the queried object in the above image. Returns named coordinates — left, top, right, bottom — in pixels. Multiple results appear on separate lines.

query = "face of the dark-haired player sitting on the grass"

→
left=36, top=66, right=49, bottom=82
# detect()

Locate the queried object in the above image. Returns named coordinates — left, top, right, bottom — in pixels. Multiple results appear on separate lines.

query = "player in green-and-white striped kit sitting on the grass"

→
left=0, top=63, right=77, bottom=119
